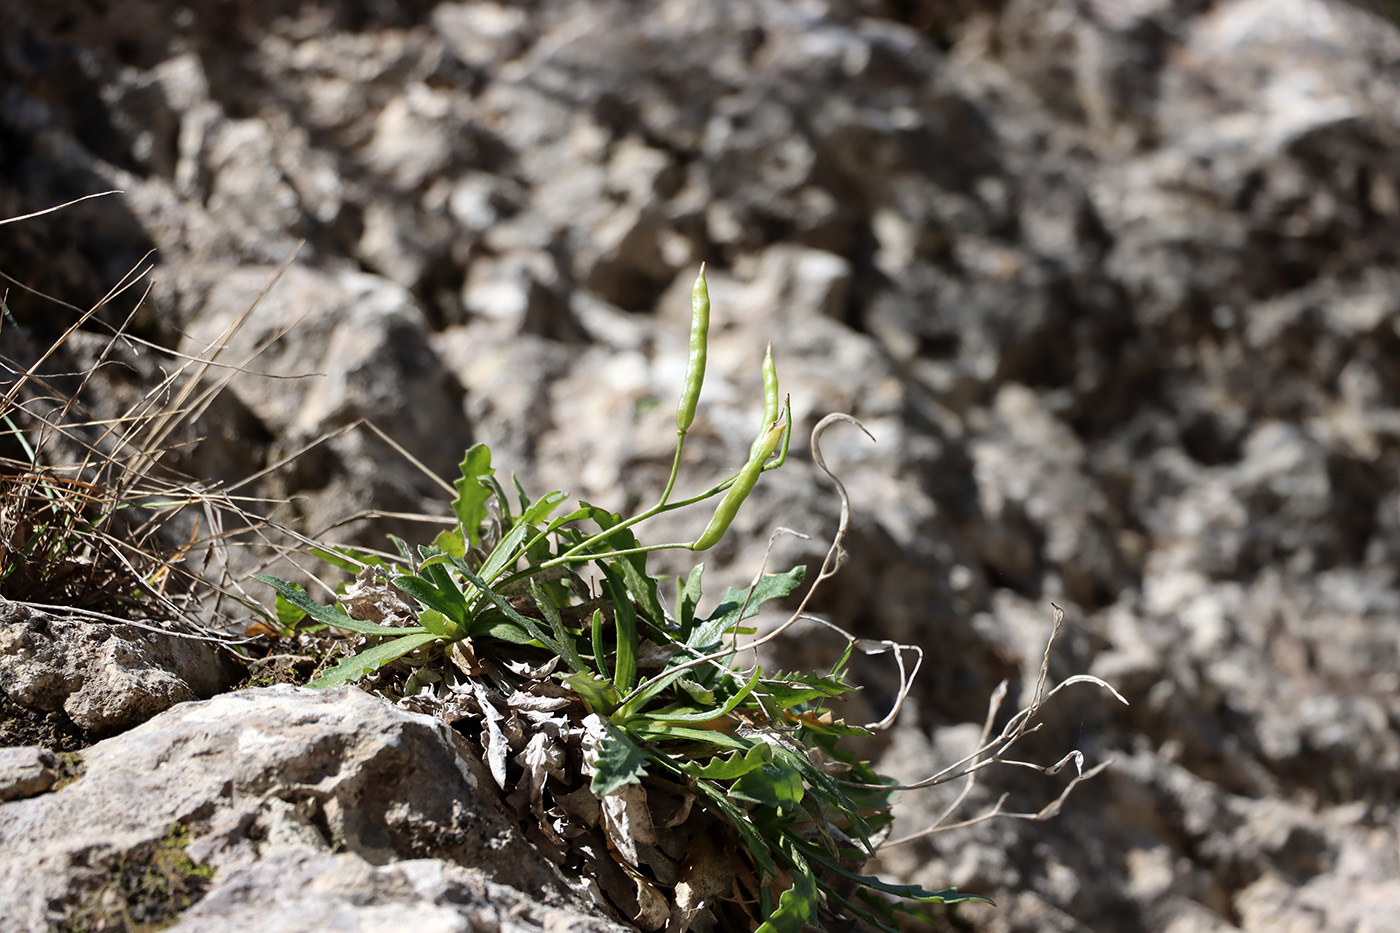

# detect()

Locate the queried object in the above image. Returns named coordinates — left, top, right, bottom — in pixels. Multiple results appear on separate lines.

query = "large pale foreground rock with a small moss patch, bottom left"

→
left=0, top=686, right=623, bottom=930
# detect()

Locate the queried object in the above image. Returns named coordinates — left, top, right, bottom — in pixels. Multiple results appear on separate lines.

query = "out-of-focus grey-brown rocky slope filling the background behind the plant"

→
left=0, top=0, right=1400, bottom=933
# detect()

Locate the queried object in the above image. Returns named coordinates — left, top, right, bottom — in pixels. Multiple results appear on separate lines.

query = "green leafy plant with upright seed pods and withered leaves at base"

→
left=259, top=268, right=1120, bottom=933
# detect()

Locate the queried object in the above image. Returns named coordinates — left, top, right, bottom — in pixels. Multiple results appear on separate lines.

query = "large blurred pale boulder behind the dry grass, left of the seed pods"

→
left=173, top=257, right=472, bottom=546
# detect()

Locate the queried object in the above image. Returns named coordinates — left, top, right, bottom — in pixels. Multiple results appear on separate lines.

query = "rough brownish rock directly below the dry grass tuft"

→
left=0, top=601, right=242, bottom=735
